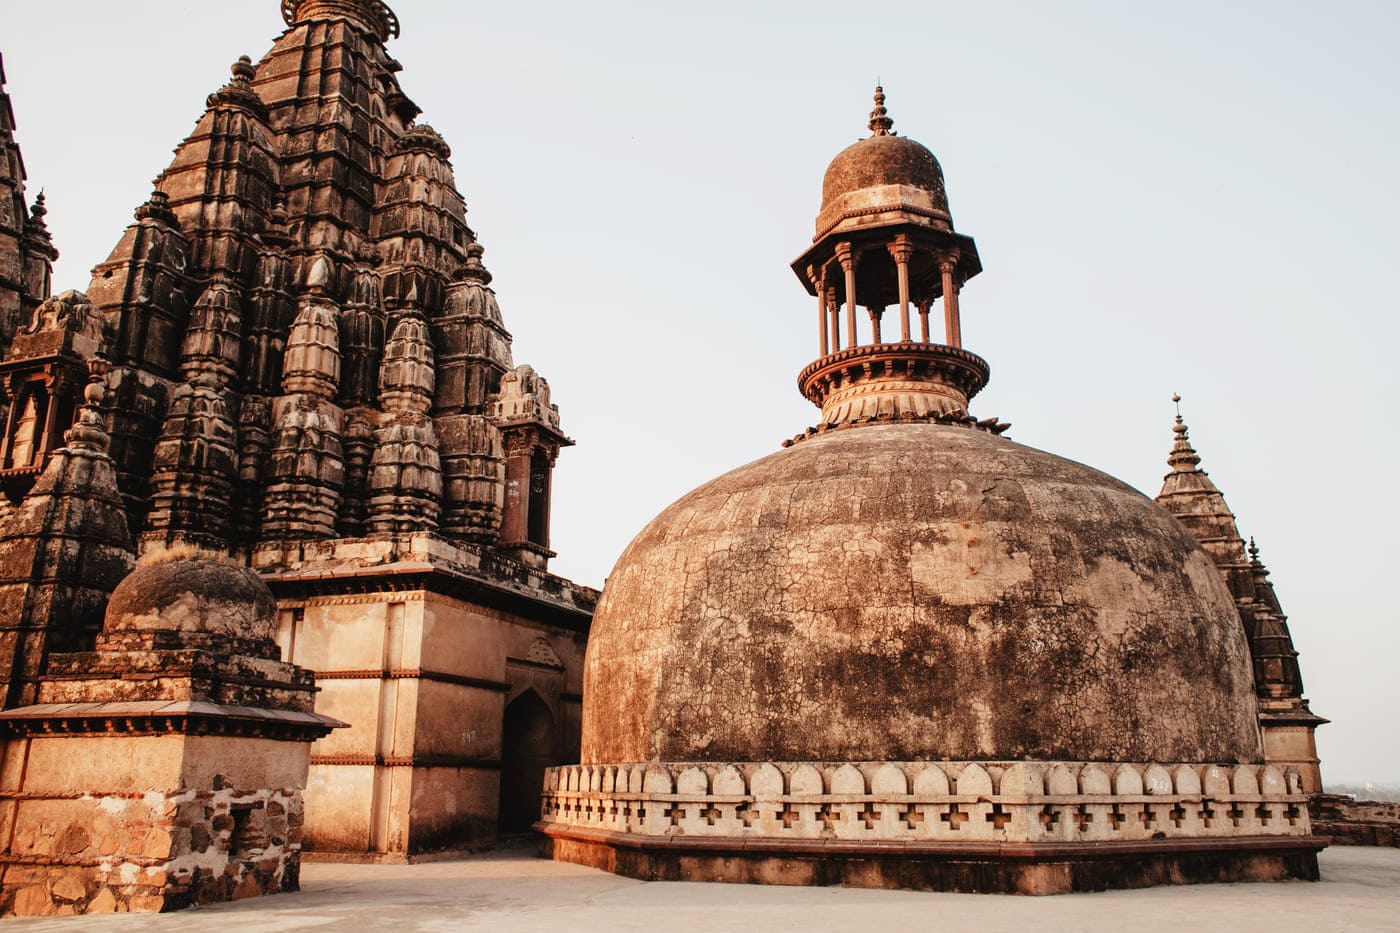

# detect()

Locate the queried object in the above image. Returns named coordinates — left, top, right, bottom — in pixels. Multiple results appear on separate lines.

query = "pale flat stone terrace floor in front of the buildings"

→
left=0, top=848, right=1400, bottom=933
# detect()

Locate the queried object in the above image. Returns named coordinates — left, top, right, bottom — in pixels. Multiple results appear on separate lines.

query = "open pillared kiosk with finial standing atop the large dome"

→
left=792, top=88, right=1007, bottom=433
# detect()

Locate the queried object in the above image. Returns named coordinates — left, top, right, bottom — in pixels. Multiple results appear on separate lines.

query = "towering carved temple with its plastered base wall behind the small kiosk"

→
left=0, top=0, right=598, bottom=857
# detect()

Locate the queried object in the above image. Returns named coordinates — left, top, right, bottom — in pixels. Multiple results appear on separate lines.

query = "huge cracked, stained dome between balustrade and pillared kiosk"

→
left=582, top=424, right=1260, bottom=763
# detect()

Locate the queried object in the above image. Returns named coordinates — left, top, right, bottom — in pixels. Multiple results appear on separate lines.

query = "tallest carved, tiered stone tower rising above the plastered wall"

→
left=66, top=0, right=567, bottom=566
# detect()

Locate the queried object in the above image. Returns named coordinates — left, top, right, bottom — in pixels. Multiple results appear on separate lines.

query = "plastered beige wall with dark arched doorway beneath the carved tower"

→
left=279, top=588, right=587, bottom=860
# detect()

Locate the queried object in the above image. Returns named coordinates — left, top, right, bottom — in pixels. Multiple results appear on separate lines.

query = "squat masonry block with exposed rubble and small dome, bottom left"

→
left=0, top=559, right=342, bottom=916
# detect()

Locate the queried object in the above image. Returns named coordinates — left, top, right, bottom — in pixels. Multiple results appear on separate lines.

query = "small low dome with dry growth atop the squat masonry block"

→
left=105, top=558, right=277, bottom=639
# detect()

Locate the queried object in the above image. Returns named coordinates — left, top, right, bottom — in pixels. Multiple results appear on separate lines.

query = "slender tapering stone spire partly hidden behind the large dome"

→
left=1156, top=396, right=1329, bottom=794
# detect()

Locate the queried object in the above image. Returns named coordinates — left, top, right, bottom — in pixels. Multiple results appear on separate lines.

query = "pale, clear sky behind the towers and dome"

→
left=0, top=0, right=1400, bottom=782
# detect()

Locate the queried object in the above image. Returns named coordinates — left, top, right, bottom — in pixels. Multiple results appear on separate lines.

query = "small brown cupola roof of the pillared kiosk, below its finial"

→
left=818, top=134, right=952, bottom=235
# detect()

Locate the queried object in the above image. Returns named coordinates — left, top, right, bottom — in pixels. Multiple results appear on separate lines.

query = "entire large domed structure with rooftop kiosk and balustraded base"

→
left=536, top=91, right=1322, bottom=894
